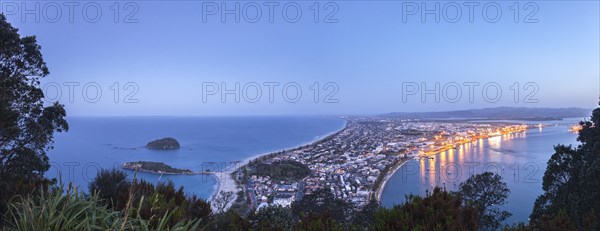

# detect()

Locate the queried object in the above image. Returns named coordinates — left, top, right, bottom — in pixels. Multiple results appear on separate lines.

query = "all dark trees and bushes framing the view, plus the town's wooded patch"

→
left=0, top=14, right=600, bottom=231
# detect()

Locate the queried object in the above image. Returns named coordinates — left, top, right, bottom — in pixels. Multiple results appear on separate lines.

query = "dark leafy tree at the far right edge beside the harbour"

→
left=530, top=104, right=600, bottom=230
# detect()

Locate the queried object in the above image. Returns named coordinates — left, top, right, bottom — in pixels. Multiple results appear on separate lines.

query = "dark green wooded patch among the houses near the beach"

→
left=247, top=160, right=311, bottom=181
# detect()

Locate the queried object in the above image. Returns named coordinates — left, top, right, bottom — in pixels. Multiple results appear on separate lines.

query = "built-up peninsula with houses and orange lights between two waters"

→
left=232, top=117, right=538, bottom=214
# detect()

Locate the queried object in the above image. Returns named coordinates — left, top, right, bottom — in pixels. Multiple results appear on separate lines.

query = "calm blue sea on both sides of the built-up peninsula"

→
left=46, top=116, right=583, bottom=224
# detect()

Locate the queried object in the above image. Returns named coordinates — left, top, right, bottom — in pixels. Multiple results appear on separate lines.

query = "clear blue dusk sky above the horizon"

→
left=0, top=0, right=600, bottom=116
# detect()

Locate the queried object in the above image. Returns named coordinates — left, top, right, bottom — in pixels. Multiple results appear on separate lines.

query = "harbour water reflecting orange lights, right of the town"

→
left=381, top=118, right=583, bottom=224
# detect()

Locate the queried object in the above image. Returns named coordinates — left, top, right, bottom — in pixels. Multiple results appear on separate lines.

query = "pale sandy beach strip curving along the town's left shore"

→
left=209, top=117, right=348, bottom=212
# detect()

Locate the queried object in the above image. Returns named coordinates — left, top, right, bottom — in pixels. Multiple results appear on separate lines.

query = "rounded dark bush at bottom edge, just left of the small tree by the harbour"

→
left=369, top=188, right=479, bottom=231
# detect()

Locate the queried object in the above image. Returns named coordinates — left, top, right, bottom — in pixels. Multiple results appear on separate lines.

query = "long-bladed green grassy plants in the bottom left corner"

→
left=5, top=183, right=200, bottom=231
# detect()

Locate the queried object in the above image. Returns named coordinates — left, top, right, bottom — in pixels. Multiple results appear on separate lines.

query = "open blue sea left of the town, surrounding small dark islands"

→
left=47, top=116, right=345, bottom=198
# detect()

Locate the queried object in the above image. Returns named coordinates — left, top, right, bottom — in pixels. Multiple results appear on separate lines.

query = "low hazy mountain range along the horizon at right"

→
left=380, top=107, right=592, bottom=120
